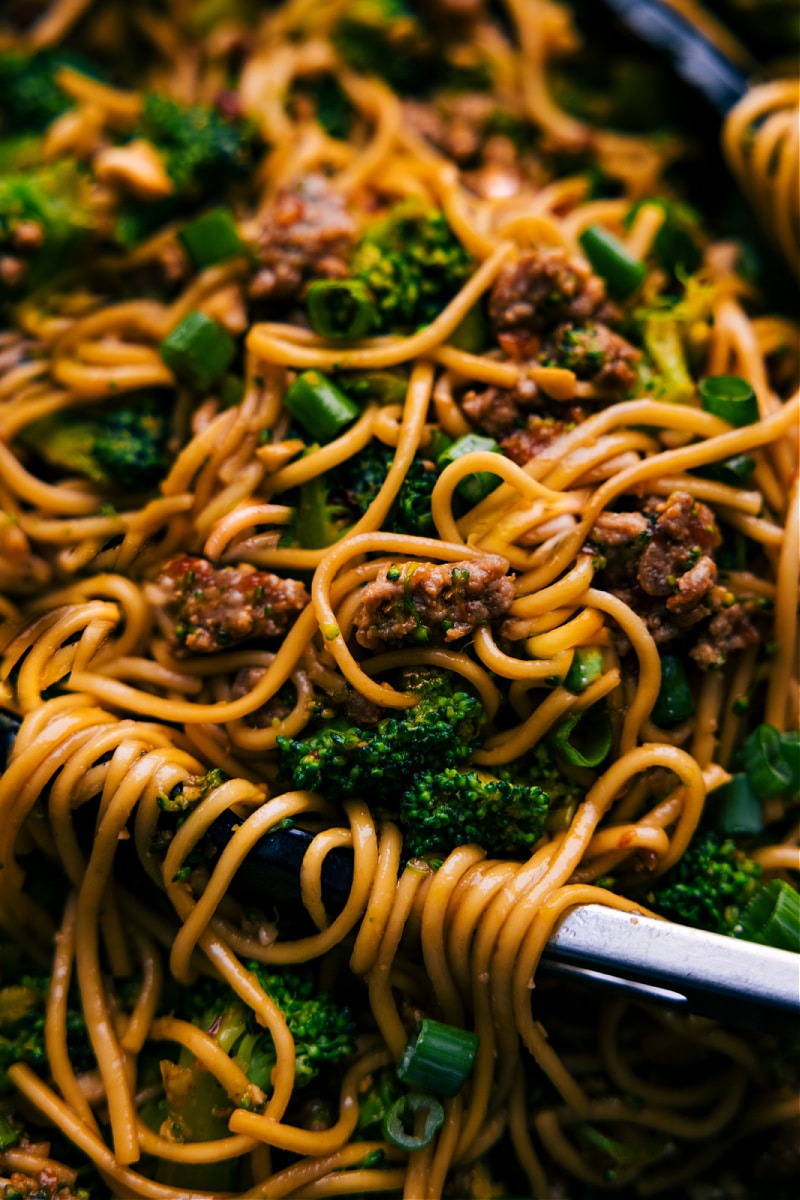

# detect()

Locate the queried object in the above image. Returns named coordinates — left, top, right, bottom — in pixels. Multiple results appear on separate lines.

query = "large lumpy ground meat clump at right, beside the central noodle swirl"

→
left=590, top=492, right=759, bottom=670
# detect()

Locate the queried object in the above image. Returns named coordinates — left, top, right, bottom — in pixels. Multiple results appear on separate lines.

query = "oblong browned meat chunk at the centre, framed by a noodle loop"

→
left=355, top=554, right=513, bottom=650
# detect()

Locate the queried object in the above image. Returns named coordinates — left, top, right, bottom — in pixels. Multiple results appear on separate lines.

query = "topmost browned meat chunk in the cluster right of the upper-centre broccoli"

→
left=489, top=247, right=606, bottom=356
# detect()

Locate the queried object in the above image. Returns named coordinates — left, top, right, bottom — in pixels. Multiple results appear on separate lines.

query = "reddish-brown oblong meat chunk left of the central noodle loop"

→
left=148, top=554, right=308, bottom=654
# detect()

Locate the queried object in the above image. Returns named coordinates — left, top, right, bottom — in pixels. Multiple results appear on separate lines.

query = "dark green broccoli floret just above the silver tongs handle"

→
left=646, top=832, right=762, bottom=934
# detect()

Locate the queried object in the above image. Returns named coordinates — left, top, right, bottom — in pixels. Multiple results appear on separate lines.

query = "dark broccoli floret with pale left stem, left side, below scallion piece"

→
left=23, top=394, right=170, bottom=492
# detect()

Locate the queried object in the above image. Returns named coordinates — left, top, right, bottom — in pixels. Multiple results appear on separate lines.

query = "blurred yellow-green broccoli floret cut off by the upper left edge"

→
left=0, top=161, right=95, bottom=292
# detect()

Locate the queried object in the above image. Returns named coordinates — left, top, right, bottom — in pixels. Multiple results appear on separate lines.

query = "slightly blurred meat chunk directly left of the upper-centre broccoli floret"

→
left=251, top=175, right=356, bottom=301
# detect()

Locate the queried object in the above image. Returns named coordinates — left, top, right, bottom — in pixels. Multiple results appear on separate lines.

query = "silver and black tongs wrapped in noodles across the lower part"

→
left=0, top=709, right=800, bottom=1032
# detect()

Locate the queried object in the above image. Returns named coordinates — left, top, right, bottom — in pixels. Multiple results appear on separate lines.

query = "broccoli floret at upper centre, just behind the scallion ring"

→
left=350, top=200, right=474, bottom=331
